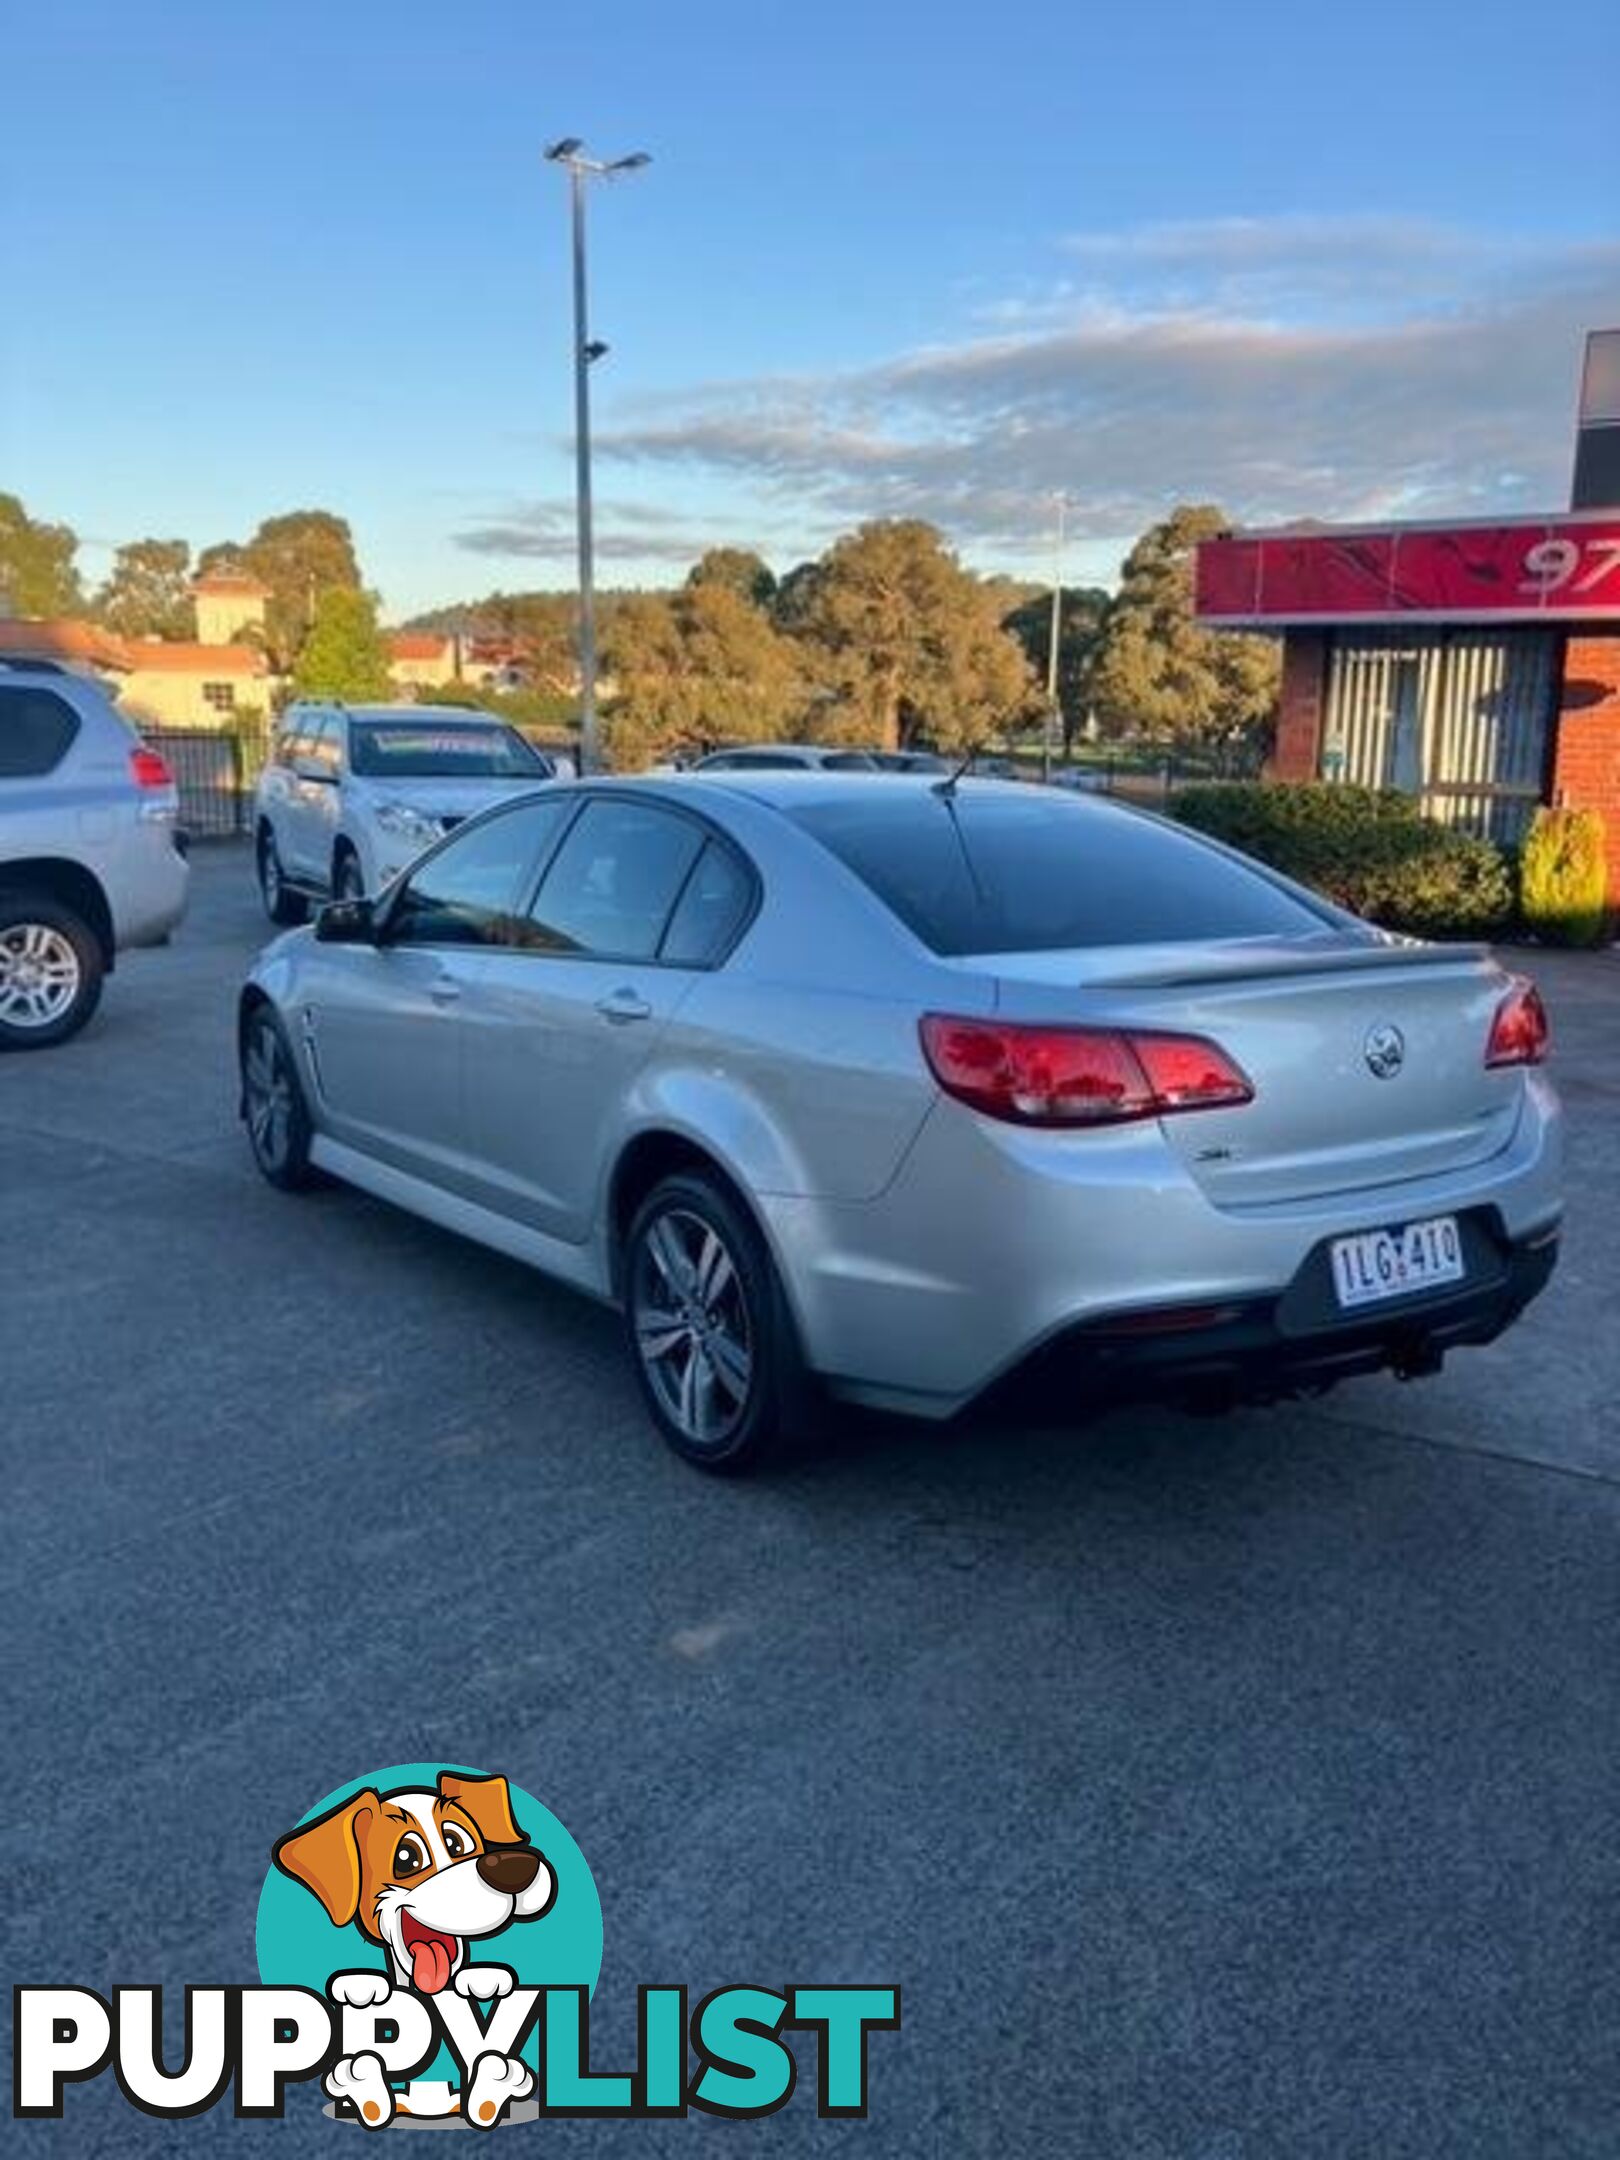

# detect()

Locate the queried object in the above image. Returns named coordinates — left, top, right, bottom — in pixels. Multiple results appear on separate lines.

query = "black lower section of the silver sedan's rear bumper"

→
left=1009, top=1210, right=1557, bottom=1402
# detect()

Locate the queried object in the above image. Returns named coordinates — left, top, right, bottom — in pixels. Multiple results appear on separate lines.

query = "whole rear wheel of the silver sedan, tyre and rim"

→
left=624, top=1171, right=814, bottom=1475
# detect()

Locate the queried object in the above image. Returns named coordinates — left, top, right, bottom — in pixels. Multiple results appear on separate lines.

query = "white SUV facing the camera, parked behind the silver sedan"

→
left=253, top=704, right=557, bottom=924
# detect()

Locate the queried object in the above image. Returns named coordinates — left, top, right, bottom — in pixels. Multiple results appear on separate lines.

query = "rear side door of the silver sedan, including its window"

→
left=467, top=795, right=752, bottom=1244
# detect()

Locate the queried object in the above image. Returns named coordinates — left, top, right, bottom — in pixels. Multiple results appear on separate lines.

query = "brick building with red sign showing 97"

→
left=1197, top=330, right=1620, bottom=905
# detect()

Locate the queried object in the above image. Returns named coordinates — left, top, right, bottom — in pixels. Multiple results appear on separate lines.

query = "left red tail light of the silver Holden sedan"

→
left=922, top=1013, right=1255, bottom=1125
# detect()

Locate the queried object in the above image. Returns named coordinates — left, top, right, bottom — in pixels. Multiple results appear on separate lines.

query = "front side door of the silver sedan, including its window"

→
left=302, top=799, right=568, bottom=1194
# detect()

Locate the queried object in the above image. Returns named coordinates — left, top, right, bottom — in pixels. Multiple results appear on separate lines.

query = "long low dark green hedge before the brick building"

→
left=1171, top=782, right=1514, bottom=937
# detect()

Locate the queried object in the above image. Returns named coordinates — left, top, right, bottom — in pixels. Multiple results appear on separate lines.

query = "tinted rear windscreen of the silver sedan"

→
left=782, top=786, right=1328, bottom=953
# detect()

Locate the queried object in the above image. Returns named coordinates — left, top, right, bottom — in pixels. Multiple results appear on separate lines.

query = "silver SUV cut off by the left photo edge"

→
left=0, top=661, right=188, bottom=1050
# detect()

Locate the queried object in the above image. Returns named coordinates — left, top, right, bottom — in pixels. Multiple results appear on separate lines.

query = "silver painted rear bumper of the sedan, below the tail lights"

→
left=760, top=1074, right=1564, bottom=1417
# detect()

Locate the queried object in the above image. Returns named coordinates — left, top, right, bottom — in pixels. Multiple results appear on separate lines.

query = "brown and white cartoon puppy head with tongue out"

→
left=272, top=1771, right=557, bottom=2002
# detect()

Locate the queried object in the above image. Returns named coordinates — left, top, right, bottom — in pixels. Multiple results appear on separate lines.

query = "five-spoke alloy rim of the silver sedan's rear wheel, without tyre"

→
left=631, top=1207, right=754, bottom=1447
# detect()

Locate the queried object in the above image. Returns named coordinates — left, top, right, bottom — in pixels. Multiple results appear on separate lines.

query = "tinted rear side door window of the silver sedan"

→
left=531, top=801, right=704, bottom=959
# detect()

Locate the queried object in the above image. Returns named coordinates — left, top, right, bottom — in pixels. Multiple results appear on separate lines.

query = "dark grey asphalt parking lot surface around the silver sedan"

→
left=0, top=847, right=1620, bottom=2160
